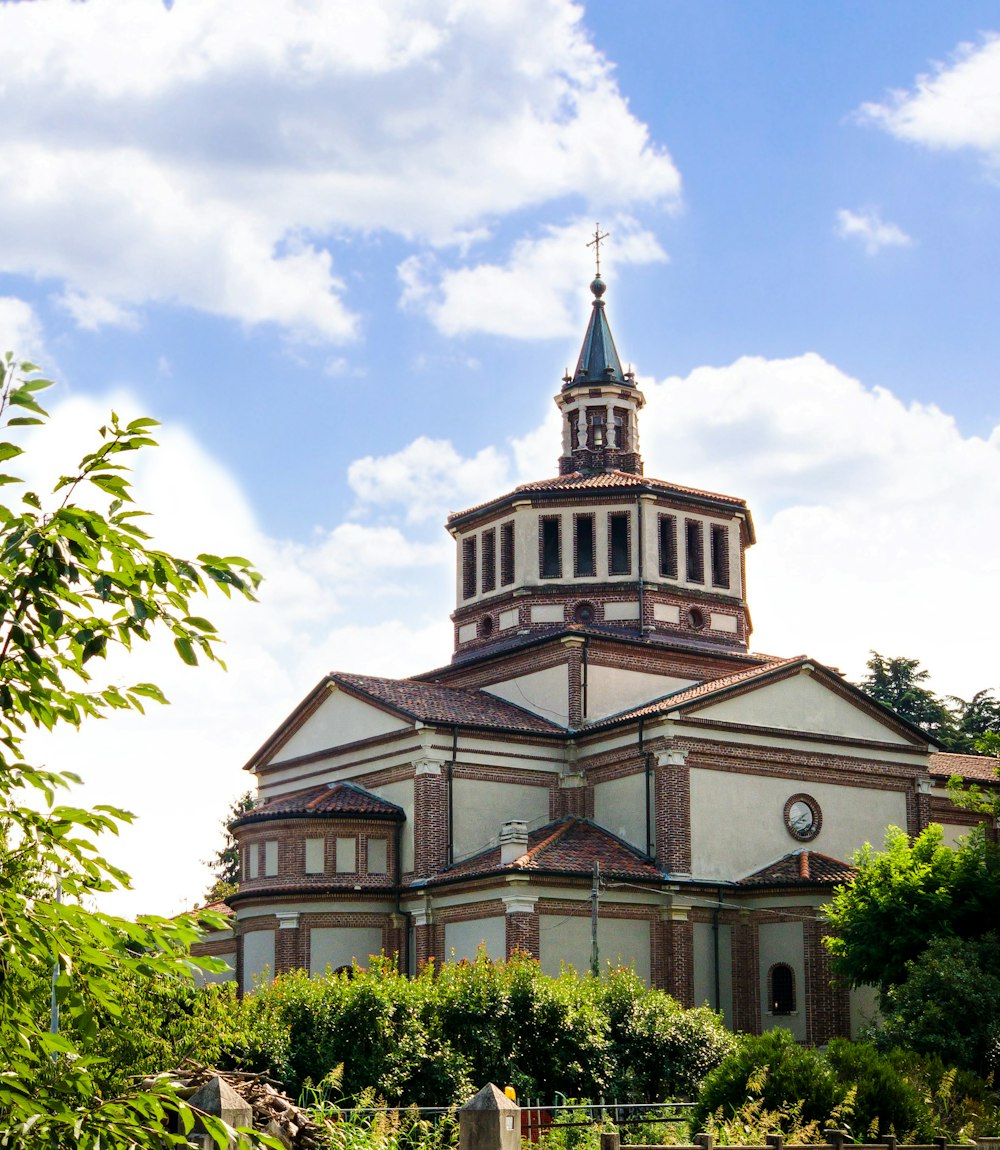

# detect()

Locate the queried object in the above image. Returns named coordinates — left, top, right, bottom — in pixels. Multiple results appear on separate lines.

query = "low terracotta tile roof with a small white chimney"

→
left=430, top=815, right=666, bottom=883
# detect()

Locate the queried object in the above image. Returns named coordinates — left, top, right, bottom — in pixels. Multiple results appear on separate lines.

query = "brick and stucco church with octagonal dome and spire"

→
left=202, top=274, right=988, bottom=1043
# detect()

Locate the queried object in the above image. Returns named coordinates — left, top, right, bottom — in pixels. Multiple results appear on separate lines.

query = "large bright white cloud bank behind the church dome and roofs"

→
left=24, top=354, right=1000, bottom=912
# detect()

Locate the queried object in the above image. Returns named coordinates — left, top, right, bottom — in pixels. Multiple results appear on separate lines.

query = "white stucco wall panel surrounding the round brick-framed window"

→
left=691, top=767, right=906, bottom=879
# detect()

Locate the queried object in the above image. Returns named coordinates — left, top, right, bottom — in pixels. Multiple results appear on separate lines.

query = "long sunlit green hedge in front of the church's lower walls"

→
left=220, top=955, right=734, bottom=1105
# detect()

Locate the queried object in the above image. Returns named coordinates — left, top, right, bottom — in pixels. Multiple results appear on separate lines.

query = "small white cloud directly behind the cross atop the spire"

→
left=399, top=216, right=667, bottom=339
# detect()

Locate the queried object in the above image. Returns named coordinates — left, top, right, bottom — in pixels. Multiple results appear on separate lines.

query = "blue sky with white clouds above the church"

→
left=0, top=0, right=1000, bottom=910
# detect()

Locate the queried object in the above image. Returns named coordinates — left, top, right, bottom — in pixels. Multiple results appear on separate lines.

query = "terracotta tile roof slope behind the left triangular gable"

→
left=328, top=672, right=566, bottom=735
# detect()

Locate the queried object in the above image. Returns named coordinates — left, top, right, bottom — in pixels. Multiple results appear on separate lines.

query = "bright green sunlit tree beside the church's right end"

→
left=824, top=823, right=1000, bottom=992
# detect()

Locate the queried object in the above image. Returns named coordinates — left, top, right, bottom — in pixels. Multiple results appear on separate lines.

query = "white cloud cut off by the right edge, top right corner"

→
left=861, top=33, right=1000, bottom=167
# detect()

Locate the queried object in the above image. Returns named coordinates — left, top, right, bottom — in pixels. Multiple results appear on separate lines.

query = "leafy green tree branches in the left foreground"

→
left=0, top=353, right=270, bottom=1150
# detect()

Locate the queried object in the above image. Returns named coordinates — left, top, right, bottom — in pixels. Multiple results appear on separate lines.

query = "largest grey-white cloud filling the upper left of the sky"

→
left=0, top=0, right=679, bottom=342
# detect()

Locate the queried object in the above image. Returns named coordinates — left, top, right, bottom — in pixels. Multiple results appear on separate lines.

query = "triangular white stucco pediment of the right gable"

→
left=698, top=674, right=909, bottom=746
